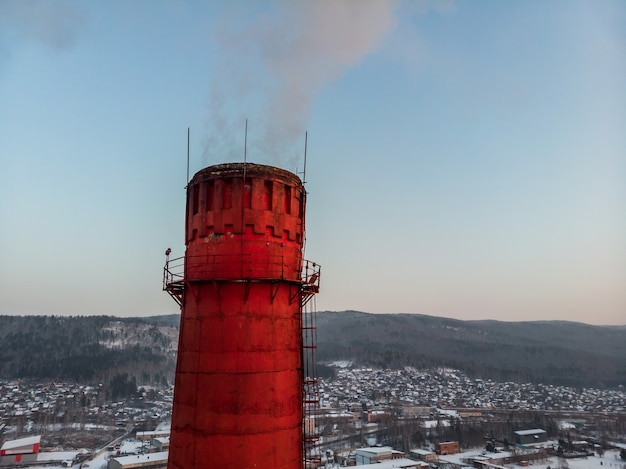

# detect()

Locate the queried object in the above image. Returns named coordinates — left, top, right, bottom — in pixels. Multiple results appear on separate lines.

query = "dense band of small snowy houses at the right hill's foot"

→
left=320, top=362, right=626, bottom=413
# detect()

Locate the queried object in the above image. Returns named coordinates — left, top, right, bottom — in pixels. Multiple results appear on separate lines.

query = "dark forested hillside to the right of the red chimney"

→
left=317, top=311, right=626, bottom=388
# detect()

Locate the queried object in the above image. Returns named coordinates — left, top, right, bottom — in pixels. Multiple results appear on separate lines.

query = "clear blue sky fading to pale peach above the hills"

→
left=0, top=0, right=626, bottom=325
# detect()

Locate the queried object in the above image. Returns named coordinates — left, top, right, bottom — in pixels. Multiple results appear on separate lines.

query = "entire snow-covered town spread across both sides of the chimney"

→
left=0, top=361, right=626, bottom=469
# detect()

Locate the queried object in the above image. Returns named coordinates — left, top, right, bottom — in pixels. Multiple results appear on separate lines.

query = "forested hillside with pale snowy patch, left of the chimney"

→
left=0, top=316, right=178, bottom=384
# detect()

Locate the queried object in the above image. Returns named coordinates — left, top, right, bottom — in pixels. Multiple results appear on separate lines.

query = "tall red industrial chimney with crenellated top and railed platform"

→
left=164, top=163, right=319, bottom=469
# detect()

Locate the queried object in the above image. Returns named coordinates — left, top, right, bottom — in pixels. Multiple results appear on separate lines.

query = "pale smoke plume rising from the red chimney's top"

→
left=205, top=0, right=396, bottom=163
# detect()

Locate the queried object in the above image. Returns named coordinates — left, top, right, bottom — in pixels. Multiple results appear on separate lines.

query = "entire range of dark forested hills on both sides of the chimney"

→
left=0, top=311, right=626, bottom=388
